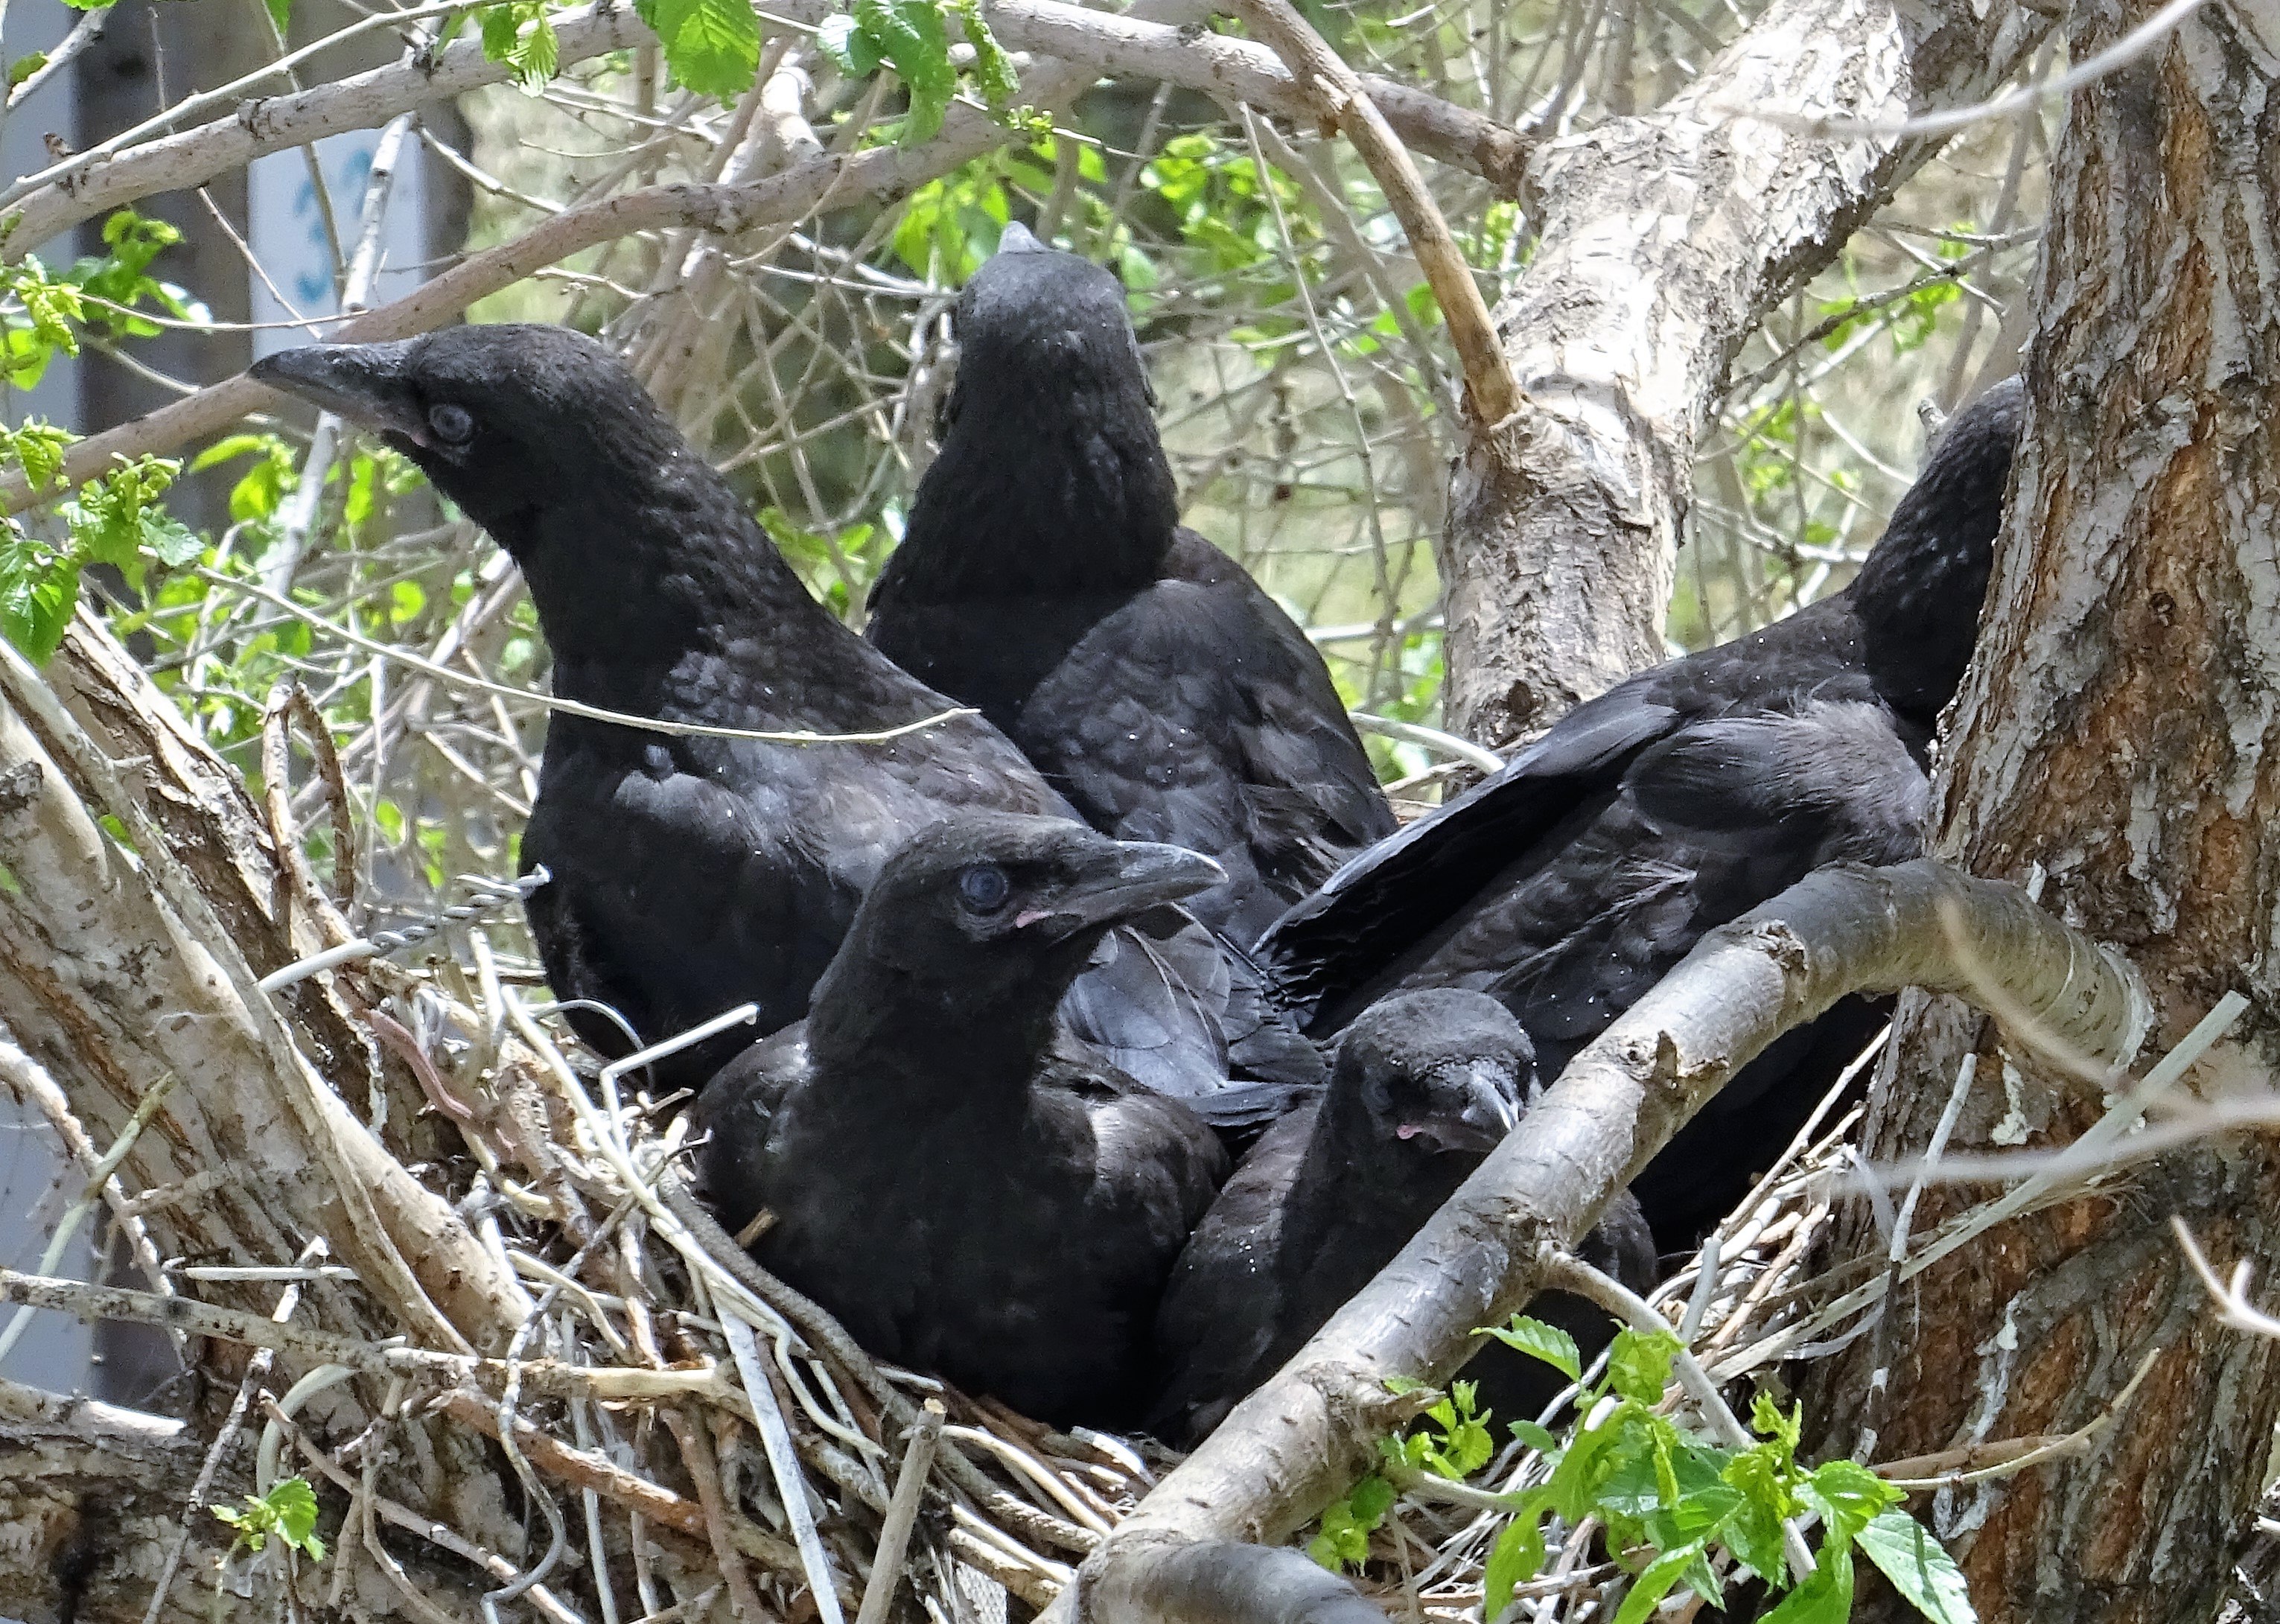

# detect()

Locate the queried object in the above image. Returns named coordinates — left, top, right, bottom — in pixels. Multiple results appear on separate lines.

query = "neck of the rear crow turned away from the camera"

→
left=896, top=410, right=1179, bottom=605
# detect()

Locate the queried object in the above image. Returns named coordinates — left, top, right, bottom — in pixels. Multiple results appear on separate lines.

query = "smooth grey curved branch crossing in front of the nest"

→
left=1048, top=860, right=2147, bottom=1617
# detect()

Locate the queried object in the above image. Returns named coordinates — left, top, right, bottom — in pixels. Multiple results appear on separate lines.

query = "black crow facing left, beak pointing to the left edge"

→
left=253, top=324, right=1318, bottom=1095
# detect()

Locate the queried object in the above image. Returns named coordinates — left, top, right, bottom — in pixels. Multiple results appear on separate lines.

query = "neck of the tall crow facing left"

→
left=492, top=459, right=870, bottom=727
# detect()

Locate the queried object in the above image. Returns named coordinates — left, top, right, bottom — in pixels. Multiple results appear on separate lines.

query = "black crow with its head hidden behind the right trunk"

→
left=1261, top=381, right=2020, bottom=1250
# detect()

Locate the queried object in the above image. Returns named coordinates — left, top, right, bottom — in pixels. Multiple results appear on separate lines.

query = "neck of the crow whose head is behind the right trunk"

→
left=1847, top=515, right=1995, bottom=727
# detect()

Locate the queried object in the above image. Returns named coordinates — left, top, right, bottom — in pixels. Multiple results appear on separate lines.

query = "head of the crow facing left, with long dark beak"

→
left=253, top=322, right=700, bottom=547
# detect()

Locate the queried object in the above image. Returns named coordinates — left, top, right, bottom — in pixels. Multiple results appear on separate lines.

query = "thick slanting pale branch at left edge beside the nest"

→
left=0, top=622, right=529, bottom=1348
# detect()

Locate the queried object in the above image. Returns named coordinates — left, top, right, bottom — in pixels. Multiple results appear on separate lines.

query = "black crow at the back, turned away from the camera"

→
left=869, top=226, right=1393, bottom=942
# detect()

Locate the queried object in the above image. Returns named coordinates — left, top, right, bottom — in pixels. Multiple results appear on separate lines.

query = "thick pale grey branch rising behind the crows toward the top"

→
left=1445, top=0, right=2050, bottom=744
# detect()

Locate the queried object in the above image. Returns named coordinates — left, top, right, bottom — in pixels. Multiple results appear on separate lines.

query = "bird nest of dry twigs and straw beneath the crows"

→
left=374, top=1013, right=1853, bottom=1624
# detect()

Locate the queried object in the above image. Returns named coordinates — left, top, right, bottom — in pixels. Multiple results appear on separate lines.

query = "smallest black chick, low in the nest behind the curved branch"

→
left=1149, top=990, right=1655, bottom=1448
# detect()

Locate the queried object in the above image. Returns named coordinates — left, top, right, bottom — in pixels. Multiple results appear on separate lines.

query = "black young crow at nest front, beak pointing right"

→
left=698, top=812, right=1226, bottom=1426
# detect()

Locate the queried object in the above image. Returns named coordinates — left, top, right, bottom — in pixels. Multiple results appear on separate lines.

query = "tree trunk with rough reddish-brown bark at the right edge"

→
left=1808, top=0, right=2280, bottom=1624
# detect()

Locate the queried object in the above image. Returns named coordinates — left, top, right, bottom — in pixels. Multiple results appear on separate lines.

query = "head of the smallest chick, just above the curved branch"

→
left=1329, top=987, right=1537, bottom=1156
